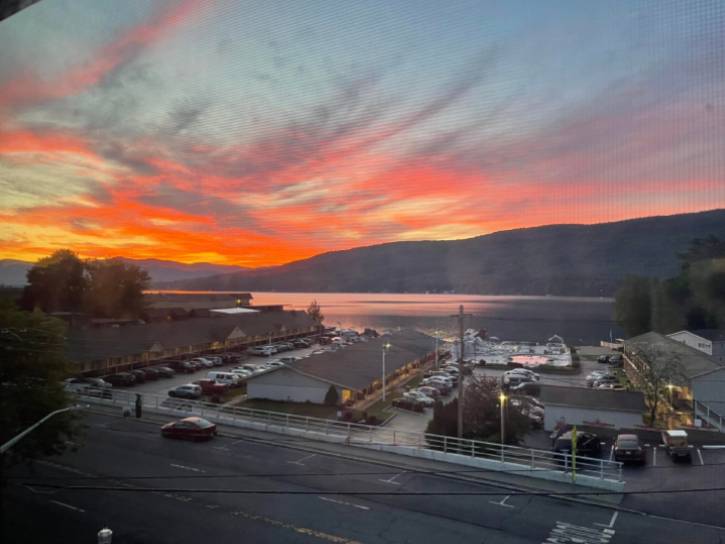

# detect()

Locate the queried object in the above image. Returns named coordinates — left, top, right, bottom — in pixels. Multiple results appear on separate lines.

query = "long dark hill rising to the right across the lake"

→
left=164, top=210, right=725, bottom=296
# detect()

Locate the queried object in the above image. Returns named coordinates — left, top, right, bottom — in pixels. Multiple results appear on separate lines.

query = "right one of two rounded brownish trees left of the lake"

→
left=85, top=259, right=151, bottom=318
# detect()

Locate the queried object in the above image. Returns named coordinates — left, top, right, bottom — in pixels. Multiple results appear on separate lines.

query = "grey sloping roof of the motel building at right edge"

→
left=624, top=331, right=723, bottom=380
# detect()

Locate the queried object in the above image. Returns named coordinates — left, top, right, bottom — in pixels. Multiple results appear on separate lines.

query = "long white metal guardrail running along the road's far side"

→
left=78, top=388, right=624, bottom=490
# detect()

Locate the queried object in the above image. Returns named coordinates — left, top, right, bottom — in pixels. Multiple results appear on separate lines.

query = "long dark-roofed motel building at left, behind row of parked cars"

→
left=66, top=311, right=321, bottom=374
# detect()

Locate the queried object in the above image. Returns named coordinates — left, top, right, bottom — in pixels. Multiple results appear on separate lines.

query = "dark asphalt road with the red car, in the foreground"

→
left=3, top=414, right=725, bottom=544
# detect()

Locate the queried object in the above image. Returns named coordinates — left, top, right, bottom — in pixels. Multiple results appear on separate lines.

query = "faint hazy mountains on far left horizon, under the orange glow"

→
left=0, top=258, right=245, bottom=286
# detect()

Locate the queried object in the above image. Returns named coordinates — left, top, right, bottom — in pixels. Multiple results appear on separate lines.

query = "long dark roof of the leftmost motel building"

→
left=66, top=311, right=314, bottom=363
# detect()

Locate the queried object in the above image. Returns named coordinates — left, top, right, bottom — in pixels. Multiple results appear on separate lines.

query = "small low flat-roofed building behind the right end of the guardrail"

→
left=539, top=385, right=645, bottom=431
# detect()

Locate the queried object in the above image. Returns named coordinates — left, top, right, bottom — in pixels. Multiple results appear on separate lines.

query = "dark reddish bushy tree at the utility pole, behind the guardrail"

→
left=426, top=377, right=529, bottom=444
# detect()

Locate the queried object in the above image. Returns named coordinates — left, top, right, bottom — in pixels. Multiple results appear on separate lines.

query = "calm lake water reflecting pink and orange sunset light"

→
left=177, top=292, right=621, bottom=344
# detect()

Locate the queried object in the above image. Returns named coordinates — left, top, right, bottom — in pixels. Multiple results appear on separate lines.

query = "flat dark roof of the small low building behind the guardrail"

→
left=539, top=385, right=645, bottom=413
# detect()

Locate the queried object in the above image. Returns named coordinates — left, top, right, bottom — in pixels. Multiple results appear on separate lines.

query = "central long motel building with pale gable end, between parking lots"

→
left=247, top=330, right=435, bottom=404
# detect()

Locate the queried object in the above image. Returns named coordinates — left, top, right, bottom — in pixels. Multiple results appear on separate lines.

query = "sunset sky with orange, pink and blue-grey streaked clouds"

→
left=0, top=0, right=725, bottom=267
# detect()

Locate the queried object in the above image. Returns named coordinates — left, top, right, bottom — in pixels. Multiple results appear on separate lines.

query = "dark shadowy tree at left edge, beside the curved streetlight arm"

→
left=0, top=303, right=76, bottom=463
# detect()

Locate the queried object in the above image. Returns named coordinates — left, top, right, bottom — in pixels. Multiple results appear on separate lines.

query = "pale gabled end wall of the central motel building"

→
left=247, top=368, right=332, bottom=404
